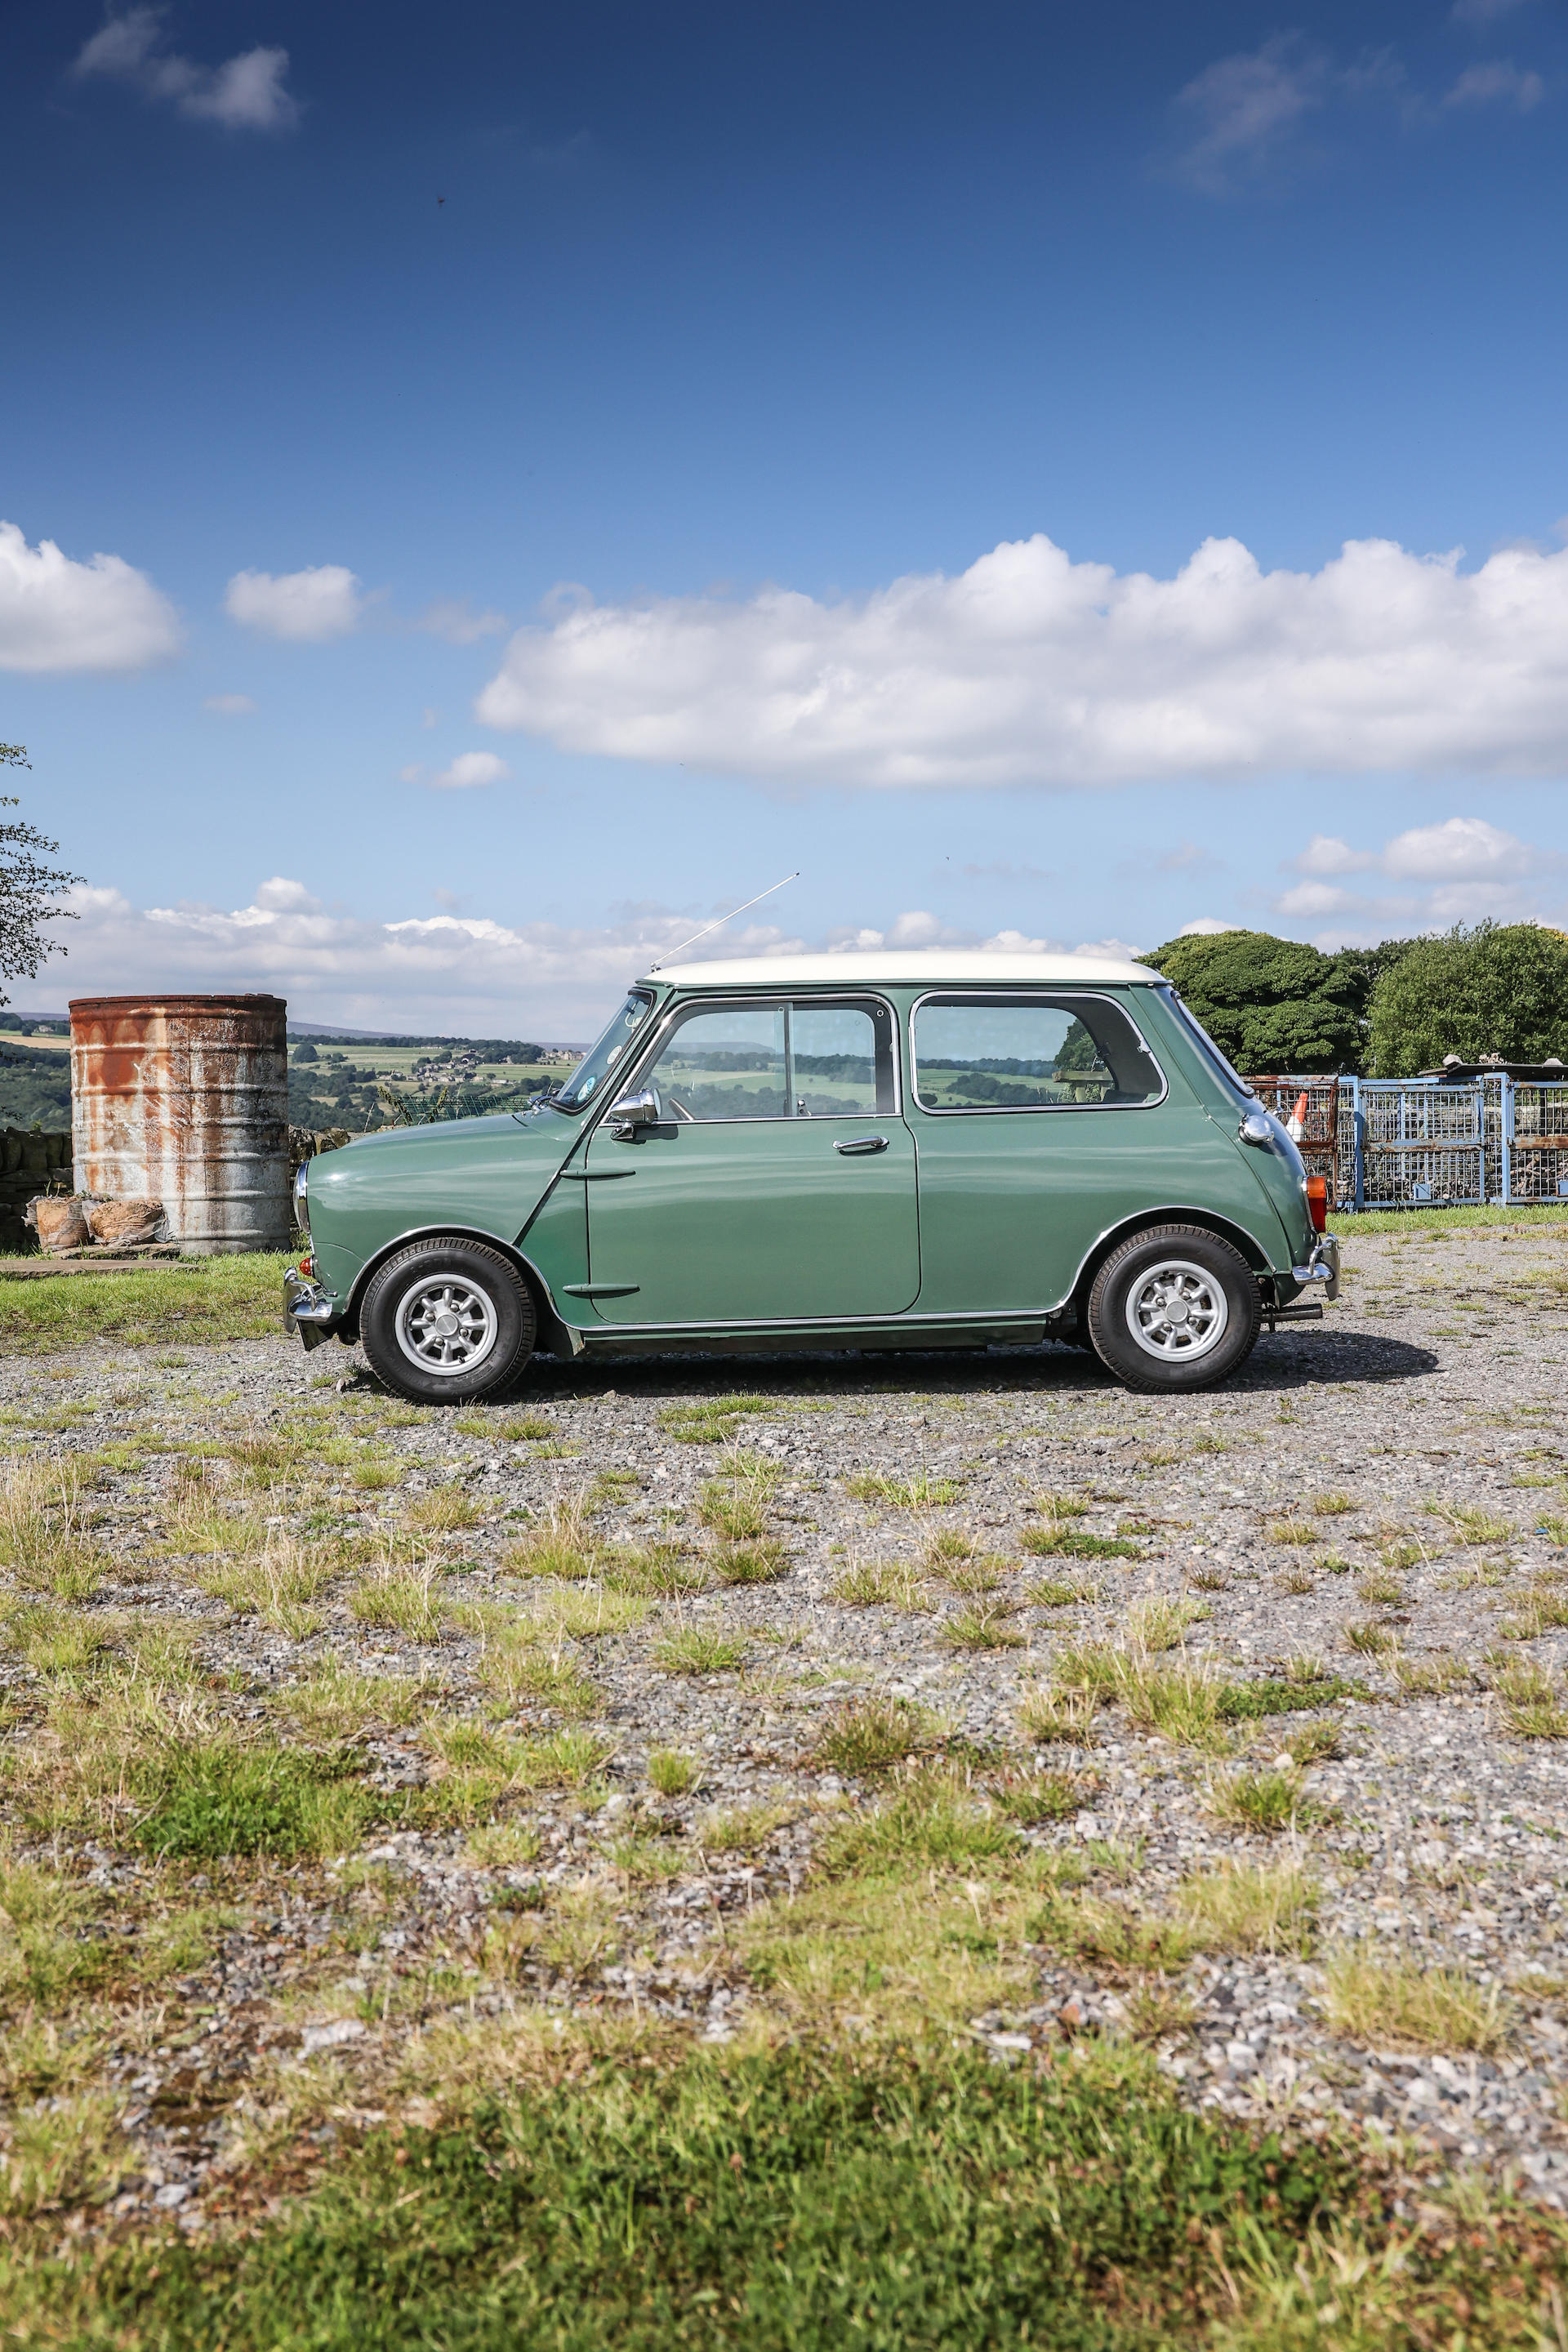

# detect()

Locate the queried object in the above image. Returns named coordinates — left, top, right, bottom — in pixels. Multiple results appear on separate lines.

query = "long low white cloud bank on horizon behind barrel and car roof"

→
left=55, top=875, right=1135, bottom=1040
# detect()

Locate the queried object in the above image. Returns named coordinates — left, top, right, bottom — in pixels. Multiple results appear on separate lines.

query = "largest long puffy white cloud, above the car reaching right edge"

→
left=477, top=534, right=1568, bottom=786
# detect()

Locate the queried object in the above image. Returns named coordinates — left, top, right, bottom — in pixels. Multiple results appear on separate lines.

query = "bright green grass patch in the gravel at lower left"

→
left=136, top=1740, right=372, bottom=1860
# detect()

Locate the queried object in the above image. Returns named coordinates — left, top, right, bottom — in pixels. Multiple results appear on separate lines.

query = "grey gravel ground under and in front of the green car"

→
left=0, top=1225, right=1568, bottom=2225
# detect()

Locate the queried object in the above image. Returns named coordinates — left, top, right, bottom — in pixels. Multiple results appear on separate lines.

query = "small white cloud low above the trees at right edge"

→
left=1274, top=816, right=1568, bottom=946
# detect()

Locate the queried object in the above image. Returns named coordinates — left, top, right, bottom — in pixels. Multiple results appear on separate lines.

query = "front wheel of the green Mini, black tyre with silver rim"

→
left=359, top=1240, right=533, bottom=1404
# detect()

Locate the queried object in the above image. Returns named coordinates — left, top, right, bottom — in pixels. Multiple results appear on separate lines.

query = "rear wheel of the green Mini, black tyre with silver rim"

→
left=1089, top=1225, right=1263, bottom=1395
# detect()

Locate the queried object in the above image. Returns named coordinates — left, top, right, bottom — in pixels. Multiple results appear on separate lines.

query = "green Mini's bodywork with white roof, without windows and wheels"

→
left=293, top=955, right=1316, bottom=1350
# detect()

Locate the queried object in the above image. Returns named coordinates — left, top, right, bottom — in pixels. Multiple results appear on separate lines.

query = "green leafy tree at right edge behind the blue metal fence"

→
left=1370, top=922, right=1568, bottom=1077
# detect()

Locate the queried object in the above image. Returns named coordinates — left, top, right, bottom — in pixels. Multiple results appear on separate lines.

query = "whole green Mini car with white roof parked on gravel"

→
left=284, top=952, right=1340, bottom=1404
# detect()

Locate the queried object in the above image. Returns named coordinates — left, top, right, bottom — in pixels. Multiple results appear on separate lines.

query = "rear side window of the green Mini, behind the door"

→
left=915, top=992, right=1166, bottom=1110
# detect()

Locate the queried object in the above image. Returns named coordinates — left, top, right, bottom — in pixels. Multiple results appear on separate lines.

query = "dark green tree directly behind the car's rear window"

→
left=1140, top=931, right=1383, bottom=1077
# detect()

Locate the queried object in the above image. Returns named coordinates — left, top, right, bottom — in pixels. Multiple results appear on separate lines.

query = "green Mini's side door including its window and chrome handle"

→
left=586, top=997, right=920, bottom=1324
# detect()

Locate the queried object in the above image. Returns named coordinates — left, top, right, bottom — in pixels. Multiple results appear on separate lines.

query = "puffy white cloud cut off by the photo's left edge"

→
left=0, top=522, right=179, bottom=673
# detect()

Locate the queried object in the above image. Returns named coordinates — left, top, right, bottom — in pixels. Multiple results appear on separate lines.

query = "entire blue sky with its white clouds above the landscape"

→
left=0, top=0, right=1568, bottom=1037
